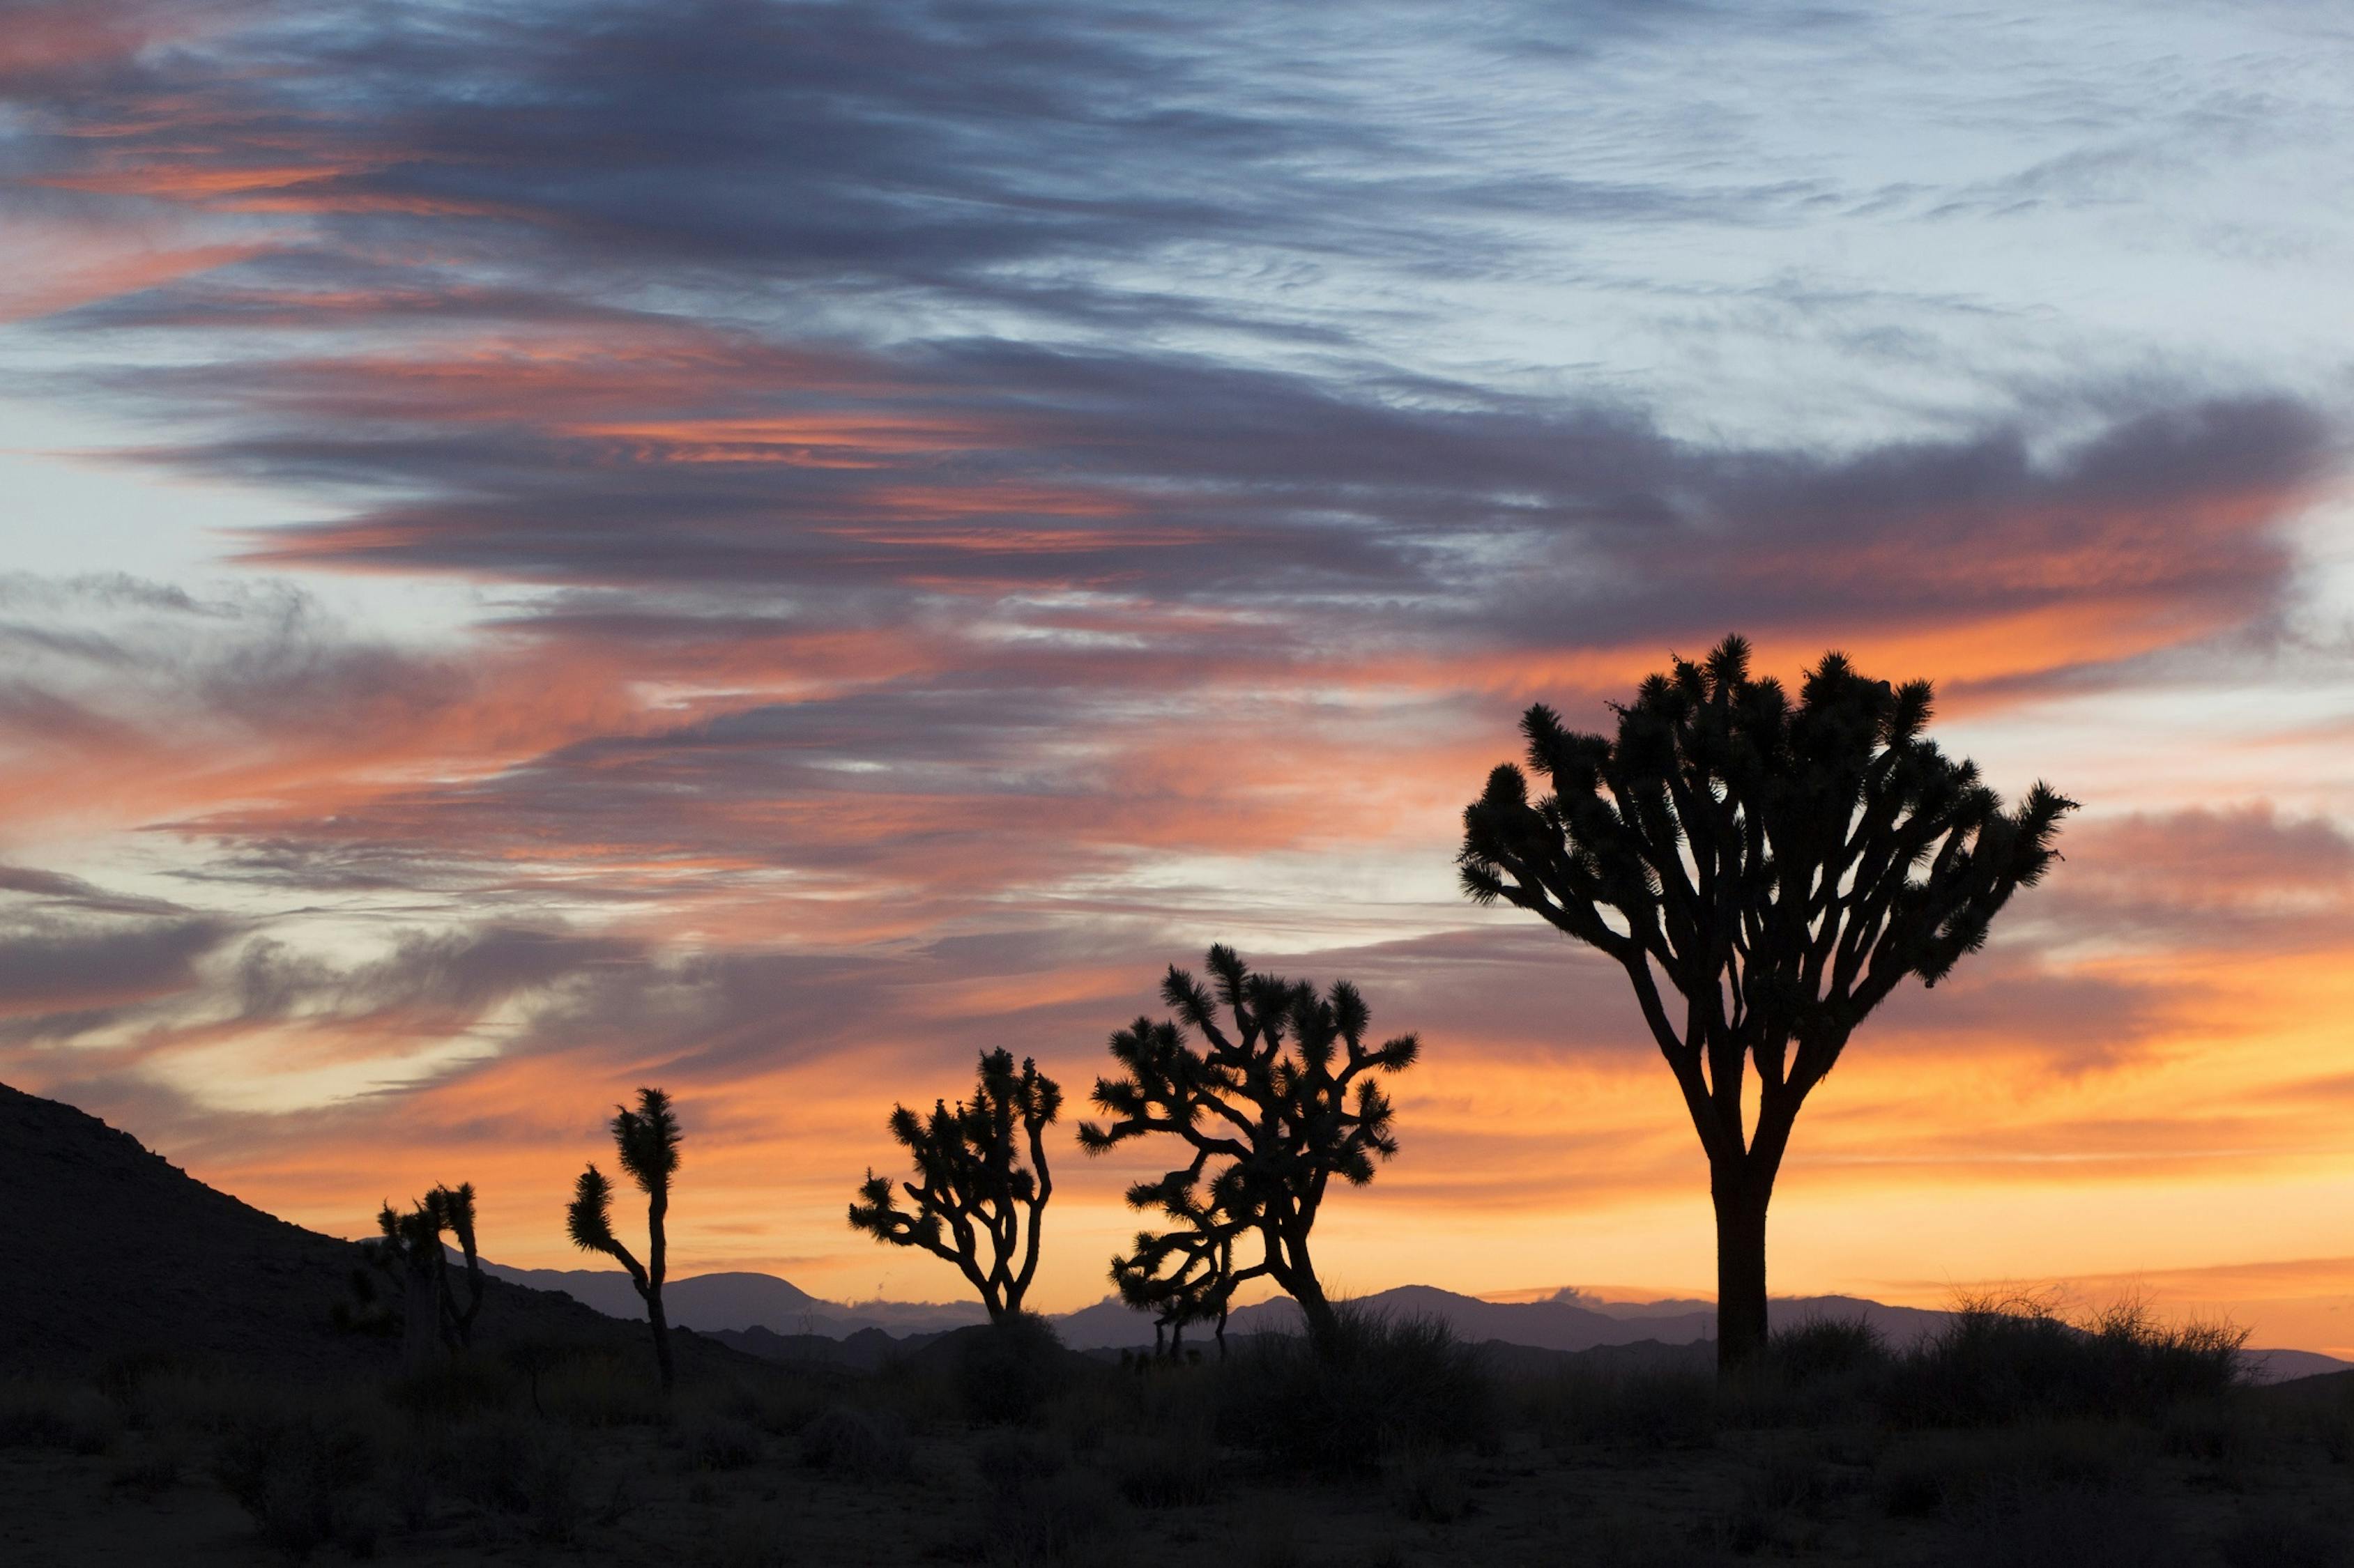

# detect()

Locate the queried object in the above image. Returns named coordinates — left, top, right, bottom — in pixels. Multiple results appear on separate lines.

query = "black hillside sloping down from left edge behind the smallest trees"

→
left=0, top=1085, right=734, bottom=1377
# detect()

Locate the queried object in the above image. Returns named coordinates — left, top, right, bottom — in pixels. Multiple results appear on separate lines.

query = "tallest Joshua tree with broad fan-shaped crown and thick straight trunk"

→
left=1457, top=638, right=2077, bottom=1368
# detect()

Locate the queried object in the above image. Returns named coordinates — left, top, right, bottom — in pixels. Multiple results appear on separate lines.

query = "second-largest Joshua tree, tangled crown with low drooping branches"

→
left=1078, top=946, right=1422, bottom=1354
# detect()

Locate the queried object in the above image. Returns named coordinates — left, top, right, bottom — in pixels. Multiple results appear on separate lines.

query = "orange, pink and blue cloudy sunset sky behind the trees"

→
left=0, top=0, right=2354, bottom=1356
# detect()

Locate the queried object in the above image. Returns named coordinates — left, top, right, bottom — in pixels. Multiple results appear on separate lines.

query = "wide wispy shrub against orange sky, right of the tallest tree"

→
left=1879, top=1300, right=2246, bottom=1427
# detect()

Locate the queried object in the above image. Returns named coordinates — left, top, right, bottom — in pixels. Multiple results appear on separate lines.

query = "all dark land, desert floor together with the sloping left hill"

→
left=0, top=1088, right=2354, bottom=1568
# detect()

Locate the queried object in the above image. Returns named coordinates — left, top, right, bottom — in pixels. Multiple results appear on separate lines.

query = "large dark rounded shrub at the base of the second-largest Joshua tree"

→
left=1203, top=1305, right=1495, bottom=1474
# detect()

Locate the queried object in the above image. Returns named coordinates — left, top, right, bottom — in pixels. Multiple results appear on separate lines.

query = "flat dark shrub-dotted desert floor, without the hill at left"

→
left=0, top=1325, right=2354, bottom=1568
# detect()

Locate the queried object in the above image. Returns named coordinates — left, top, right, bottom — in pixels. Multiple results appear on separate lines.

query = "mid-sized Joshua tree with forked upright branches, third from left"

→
left=850, top=1050, right=1062, bottom=1323
